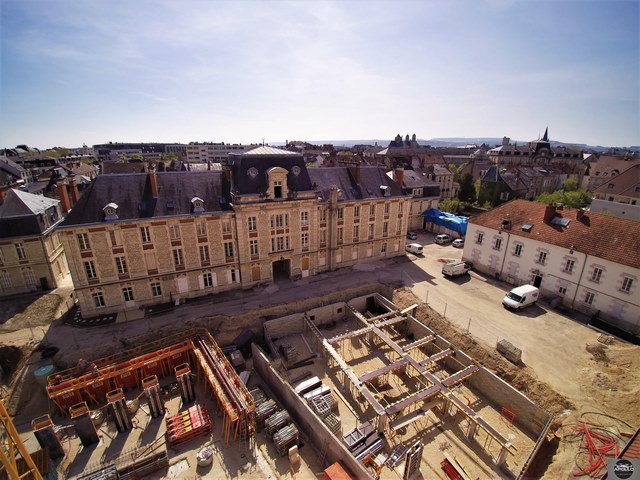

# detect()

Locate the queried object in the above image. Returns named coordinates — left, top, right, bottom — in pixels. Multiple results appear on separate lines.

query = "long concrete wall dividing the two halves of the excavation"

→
left=251, top=344, right=372, bottom=478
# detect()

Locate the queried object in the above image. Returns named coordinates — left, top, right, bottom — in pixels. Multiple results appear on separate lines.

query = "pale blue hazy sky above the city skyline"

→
left=0, top=0, right=640, bottom=148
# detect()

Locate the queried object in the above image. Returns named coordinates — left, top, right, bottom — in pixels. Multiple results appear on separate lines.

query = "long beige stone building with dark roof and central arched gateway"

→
left=60, top=147, right=410, bottom=317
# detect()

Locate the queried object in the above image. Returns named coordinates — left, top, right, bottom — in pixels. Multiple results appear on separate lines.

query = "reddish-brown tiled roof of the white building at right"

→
left=469, top=200, right=640, bottom=268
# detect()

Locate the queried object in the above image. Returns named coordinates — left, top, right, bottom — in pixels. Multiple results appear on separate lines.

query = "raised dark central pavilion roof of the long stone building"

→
left=229, top=147, right=313, bottom=195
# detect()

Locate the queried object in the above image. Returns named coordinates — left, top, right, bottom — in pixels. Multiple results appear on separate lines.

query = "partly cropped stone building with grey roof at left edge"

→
left=0, top=189, right=69, bottom=296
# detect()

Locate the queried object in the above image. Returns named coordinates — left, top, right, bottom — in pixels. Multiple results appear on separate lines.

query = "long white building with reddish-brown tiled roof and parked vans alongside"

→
left=463, top=200, right=640, bottom=336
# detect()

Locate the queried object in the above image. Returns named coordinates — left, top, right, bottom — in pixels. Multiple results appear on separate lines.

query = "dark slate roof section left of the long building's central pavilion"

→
left=61, top=171, right=229, bottom=227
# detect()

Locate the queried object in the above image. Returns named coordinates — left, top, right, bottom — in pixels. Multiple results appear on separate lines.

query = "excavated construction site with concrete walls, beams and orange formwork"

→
left=0, top=282, right=627, bottom=480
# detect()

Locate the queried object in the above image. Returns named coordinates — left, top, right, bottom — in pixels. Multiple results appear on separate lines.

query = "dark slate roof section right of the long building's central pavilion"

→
left=309, top=167, right=402, bottom=201
